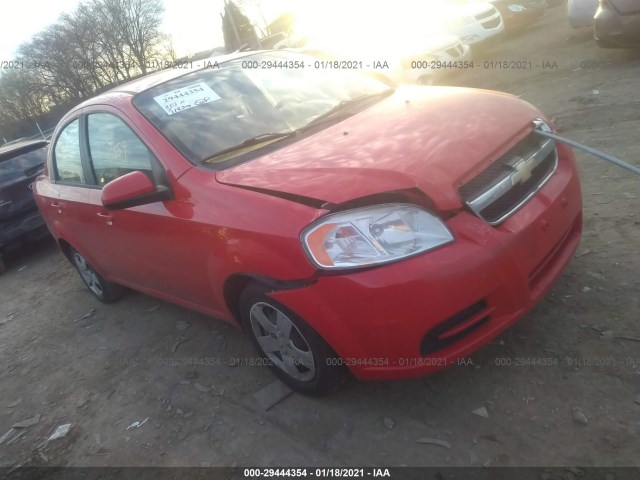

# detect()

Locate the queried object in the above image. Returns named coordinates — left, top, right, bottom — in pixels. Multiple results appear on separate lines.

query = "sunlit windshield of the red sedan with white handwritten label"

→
left=134, top=52, right=389, bottom=166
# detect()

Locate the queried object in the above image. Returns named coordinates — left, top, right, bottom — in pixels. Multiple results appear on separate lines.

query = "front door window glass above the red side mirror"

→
left=88, top=113, right=153, bottom=186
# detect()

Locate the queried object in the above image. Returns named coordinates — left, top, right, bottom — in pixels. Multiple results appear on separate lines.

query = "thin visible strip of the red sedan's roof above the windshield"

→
left=73, top=50, right=265, bottom=111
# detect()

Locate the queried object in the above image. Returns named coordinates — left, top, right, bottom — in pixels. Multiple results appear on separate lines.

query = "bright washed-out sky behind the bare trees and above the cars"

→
left=0, top=0, right=450, bottom=64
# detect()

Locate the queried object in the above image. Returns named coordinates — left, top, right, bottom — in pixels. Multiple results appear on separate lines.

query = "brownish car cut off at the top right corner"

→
left=593, top=0, right=640, bottom=48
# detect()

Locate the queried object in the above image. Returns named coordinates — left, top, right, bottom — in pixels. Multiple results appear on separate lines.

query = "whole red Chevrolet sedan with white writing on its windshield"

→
left=34, top=52, right=582, bottom=394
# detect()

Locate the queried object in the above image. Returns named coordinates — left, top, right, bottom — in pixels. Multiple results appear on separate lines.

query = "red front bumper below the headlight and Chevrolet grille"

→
left=272, top=141, right=582, bottom=379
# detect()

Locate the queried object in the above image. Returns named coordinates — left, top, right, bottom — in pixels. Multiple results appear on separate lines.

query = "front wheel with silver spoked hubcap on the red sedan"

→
left=239, top=283, right=348, bottom=396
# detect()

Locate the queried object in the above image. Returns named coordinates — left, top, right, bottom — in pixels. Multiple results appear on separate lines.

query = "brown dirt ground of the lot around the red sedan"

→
left=0, top=2, right=640, bottom=466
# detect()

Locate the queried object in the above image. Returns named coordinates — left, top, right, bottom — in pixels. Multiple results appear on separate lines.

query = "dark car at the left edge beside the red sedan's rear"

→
left=0, top=140, right=49, bottom=272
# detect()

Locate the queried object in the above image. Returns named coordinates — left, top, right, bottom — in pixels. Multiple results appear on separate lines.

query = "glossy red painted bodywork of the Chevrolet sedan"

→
left=34, top=79, right=582, bottom=378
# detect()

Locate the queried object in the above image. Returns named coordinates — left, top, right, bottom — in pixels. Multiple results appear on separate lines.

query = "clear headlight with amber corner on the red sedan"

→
left=302, top=204, right=453, bottom=269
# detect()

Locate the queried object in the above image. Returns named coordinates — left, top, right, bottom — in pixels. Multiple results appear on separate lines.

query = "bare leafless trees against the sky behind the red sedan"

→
left=0, top=0, right=175, bottom=144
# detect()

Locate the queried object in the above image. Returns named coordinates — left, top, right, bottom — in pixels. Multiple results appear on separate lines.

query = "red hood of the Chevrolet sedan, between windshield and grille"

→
left=216, top=87, right=540, bottom=210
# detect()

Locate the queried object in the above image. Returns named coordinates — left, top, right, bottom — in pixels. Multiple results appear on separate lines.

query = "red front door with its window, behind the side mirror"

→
left=78, top=112, right=216, bottom=308
